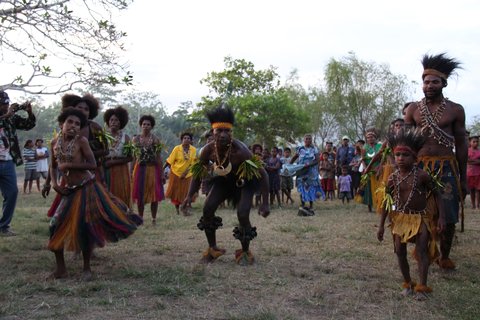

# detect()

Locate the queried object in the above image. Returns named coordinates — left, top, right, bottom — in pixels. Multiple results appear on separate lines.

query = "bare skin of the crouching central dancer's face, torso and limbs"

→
left=182, top=128, right=270, bottom=258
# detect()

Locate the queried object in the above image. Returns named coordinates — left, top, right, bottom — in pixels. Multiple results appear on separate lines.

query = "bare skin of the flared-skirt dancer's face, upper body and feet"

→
left=49, top=115, right=97, bottom=280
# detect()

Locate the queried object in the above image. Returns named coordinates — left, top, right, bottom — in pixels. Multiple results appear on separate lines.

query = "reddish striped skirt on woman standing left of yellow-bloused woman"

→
left=132, top=162, right=165, bottom=205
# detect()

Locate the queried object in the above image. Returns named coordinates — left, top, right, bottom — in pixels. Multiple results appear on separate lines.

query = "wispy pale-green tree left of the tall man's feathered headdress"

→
left=325, top=53, right=410, bottom=138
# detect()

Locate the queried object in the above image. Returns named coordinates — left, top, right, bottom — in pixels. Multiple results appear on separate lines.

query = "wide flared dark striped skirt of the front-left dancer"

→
left=48, top=179, right=142, bottom=251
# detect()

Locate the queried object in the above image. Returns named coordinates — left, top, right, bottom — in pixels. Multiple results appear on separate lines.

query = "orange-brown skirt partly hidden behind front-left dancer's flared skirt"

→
left=105, top=163, right=132, bottom=207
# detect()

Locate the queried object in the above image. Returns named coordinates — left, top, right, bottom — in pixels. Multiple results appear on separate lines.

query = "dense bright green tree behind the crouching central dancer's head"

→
left=197, top=57, right=308, bottom=146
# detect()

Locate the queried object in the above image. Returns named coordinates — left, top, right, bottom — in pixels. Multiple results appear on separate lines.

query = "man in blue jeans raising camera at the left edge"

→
left=0, top=91, right=35, bottom=237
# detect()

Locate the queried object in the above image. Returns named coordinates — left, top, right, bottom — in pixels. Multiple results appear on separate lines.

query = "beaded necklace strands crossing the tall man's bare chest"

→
left=420, top=98, right=455, bottom=149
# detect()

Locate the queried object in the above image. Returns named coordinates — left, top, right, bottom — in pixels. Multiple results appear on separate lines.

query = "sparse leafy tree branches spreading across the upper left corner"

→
left=0, top=0, right=132, bottom=94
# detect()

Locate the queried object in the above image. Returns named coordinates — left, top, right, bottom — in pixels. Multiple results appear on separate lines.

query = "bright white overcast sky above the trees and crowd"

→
left=114, top=0, right=480, bottom=121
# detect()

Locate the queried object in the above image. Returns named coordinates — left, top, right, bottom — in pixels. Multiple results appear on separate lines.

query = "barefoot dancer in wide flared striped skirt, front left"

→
left=48, top=108, right=142, bottom=280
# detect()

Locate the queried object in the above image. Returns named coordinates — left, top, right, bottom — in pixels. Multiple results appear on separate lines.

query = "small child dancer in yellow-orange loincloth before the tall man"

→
left=377, top=130, right=445, bottom=300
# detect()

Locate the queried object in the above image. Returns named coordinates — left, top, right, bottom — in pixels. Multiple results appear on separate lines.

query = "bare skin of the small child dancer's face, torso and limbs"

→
left=377, top=151, right=445, bottom=292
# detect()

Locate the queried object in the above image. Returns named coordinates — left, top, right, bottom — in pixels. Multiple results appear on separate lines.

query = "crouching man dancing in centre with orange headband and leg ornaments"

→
left=182, top=107, right=270, bottom=264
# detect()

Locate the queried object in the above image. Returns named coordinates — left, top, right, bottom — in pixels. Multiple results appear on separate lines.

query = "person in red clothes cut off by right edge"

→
left=467, top=136, right=480, bottom=209
